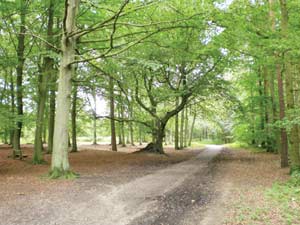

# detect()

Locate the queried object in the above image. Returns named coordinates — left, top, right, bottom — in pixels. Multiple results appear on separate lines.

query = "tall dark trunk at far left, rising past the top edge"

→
left=13, top=0, right=27, bottom=159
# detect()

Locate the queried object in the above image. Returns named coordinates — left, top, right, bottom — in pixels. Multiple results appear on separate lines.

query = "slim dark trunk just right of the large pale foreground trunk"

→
left=71, top=85, right=78, bottom=152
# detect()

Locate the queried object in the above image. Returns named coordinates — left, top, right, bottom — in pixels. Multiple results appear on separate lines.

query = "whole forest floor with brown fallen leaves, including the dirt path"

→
left=0, top=145, right=300, bottom=225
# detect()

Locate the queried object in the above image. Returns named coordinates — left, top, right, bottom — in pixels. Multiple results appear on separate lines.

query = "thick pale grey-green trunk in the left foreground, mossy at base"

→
left=50, top=0, right=79, bottom=178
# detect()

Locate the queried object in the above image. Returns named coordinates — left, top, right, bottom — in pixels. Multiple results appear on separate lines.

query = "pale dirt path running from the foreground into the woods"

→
left=0, top=146, right=222, bottom=225
